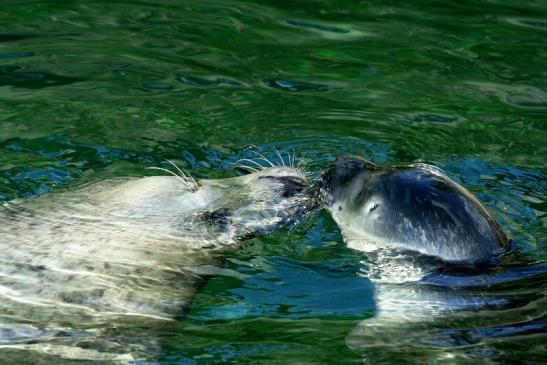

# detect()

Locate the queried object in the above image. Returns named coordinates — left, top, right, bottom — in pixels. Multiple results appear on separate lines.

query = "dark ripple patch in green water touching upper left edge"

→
left=0, top=65, right=81, bottom=89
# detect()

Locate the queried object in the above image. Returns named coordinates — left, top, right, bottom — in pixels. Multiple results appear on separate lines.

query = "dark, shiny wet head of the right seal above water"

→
left=318, top=156, right=510, bottom=262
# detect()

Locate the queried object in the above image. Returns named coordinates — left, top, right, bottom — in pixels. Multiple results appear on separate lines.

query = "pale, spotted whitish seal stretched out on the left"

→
left=0, top=166, right=308, bottom=363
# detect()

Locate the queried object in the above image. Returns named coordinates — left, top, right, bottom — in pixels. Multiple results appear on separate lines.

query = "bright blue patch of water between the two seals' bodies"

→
left=191, top=252, right=374, bottom=321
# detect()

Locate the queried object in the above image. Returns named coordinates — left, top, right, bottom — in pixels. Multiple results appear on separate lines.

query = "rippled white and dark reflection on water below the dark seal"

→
left=347, top=250, right=547, bottom=363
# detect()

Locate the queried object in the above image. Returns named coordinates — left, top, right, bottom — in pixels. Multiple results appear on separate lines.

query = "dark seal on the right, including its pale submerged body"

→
left=314, top=156, right=510, bottom=363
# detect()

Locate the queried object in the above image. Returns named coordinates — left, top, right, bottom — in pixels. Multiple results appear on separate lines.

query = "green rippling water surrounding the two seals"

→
left=0, top=0, right=547, bottom=364
